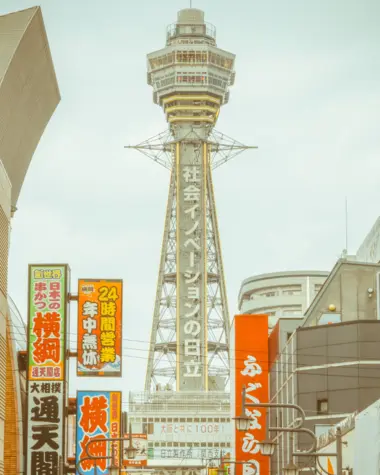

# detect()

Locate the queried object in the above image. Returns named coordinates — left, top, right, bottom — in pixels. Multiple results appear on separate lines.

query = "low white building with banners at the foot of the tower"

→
left=128, top=391, right=232, bottom=467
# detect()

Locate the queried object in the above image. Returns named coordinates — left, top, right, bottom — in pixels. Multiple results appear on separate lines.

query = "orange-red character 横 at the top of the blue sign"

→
left=79, top=395, right=108, bottom=434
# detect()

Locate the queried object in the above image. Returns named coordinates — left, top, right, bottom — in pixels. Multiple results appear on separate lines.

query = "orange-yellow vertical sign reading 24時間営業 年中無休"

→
left=77, top=279, right=123, bottom=377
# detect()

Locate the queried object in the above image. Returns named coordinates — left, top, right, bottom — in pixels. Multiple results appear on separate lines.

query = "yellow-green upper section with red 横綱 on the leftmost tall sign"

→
left=28, top=265, right=67, bottom=381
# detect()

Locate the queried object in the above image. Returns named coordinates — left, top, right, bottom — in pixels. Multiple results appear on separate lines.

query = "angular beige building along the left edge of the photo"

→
left=0, top=7, right=60, bottom=475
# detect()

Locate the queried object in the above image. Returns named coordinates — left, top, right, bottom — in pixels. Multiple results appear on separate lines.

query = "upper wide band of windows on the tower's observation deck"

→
left=149, top=51, right=233, bottom=71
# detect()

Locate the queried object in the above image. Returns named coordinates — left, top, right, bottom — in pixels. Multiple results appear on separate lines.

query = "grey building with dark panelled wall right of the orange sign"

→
left=269, top=259, right=380, bottom=475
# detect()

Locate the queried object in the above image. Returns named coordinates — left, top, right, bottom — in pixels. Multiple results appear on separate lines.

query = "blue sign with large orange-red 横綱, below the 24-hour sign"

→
left=76, top=391, right=121, bottom=475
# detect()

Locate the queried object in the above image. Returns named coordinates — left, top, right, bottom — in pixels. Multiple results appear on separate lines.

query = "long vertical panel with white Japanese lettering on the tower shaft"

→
left=176, top=142, right=208, bottom=390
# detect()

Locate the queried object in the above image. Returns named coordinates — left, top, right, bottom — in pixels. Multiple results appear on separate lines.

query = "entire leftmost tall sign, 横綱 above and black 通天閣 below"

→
left=26, top=265, right=68, bottom=475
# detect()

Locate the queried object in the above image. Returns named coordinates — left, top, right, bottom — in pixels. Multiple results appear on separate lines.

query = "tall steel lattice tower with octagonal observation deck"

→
left=129, top=8, right=254, bottom=391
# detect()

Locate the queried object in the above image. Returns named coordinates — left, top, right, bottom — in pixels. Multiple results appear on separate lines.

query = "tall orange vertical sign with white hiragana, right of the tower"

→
left=230, top=315, right=269, bottom=475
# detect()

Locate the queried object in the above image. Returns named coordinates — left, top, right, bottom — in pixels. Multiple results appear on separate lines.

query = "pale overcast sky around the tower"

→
left=0, top=0, right=380, bottom=399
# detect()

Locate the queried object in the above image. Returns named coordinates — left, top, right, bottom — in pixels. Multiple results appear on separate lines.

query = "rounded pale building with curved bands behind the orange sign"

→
left=238, top=271, right=329, bottom=328
